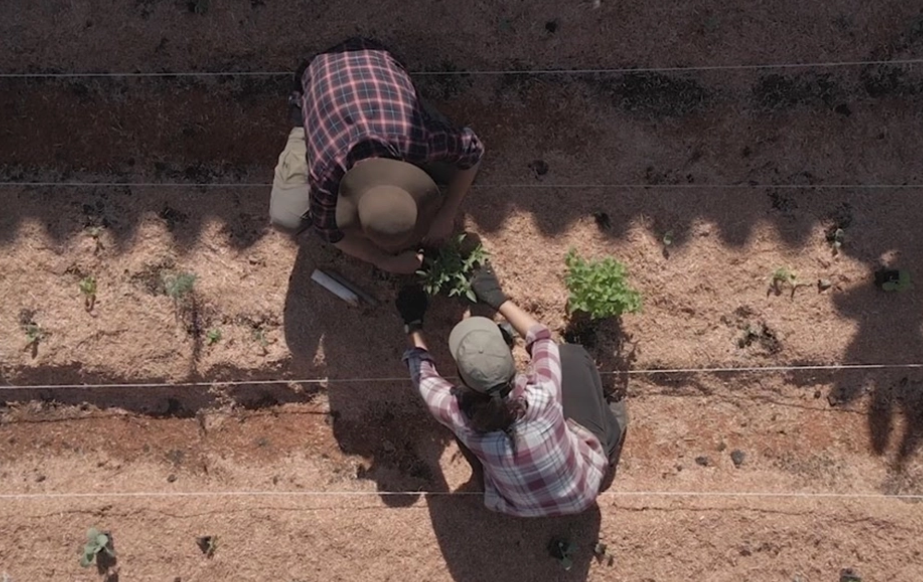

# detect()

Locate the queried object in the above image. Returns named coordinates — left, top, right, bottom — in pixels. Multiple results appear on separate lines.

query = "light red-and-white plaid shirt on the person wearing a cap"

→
left=404, top=325, right=609, bottom=517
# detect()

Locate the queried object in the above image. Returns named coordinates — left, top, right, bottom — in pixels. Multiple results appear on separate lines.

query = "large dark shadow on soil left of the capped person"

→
left=283, top=241, right=463, bottom=506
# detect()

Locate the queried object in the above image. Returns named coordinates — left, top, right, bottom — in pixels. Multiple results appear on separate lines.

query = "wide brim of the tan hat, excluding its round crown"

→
left=336, top=158, right=442, bottom=246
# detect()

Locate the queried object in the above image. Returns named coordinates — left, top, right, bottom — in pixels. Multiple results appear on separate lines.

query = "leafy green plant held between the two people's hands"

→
left=417, top=234, right=488, bottom=302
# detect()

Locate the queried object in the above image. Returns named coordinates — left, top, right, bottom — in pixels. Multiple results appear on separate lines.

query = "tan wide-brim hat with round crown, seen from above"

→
left=336, top=158, right=442, bottom=251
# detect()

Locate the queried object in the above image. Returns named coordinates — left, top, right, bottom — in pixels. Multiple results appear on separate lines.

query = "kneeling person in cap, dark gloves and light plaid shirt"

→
left=397, top=267, right=628, bottom=517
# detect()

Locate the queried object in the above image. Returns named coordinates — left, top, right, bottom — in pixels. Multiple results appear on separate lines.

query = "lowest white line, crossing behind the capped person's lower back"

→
left=0, top=490, right=923, bottom=501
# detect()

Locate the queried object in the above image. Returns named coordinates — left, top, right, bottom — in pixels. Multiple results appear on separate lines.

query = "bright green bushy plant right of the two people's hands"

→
left=564, top=249, right=641, bottom=320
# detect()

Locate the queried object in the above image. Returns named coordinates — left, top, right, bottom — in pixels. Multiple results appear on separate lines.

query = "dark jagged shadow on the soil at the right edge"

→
left=830, top=280, right=923, bottom=470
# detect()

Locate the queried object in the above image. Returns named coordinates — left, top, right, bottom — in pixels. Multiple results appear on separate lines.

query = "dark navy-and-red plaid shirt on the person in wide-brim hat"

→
left=301, top=39, right=484, bottom=243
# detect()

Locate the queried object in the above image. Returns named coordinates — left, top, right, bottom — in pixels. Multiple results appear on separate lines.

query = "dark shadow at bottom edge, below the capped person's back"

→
left=427, top=495, right=601, bottom=582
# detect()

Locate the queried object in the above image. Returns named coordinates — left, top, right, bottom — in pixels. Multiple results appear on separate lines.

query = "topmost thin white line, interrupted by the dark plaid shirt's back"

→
left=0, top=58, right=923, bottom=79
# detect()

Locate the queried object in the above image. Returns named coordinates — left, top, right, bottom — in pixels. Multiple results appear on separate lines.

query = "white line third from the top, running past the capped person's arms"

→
left=0, top=364, right=923, bottom=392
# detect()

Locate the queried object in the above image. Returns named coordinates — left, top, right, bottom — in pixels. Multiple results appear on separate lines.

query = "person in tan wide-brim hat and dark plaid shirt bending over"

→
left=270, top=38, right=484, bottom=274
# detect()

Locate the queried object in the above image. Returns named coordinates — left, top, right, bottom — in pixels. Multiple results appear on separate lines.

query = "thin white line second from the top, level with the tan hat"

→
left=0, top=182, right=923, bottom=190
